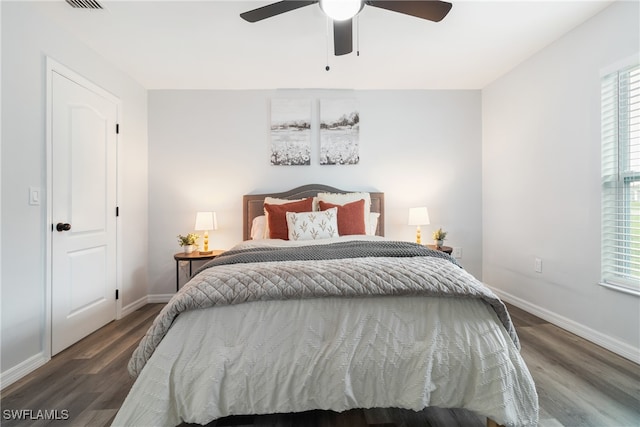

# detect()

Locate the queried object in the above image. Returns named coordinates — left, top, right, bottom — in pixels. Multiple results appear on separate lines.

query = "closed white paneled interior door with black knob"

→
left=51, top=70, right=118, bottom=355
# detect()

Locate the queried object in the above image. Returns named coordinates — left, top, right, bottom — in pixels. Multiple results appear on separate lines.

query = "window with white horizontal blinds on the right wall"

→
left=601, top=64, right=640, bottom=295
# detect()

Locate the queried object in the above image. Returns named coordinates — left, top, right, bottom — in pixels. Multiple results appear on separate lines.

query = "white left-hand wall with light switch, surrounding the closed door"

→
left=0, top=2, right=148, bottom=385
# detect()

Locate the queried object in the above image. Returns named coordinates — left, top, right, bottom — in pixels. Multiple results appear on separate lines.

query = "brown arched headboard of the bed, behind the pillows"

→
left=242, top=184, right=384, bottom=240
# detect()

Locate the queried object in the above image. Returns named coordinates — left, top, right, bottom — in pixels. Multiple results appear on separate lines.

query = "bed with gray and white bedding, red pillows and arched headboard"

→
left=113, top=185, right=538, bottom=426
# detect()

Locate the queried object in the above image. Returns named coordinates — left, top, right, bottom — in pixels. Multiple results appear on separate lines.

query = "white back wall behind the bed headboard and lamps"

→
left=149, top=90, right=482, bottom=295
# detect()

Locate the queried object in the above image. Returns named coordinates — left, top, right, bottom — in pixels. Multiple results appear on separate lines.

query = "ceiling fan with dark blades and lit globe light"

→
left=240, top=0, right=453, bottom=55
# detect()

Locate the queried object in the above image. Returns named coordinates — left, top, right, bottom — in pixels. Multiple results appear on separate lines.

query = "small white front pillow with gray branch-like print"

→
left=287, top=208, right=338, bottom=240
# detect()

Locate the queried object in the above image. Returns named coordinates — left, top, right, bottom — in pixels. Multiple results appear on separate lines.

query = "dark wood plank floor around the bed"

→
left=0, top=304, right=640, bottom=427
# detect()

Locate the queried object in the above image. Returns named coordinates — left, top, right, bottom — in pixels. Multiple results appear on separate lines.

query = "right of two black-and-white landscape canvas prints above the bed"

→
left=320, top=99, right=360, bottom=165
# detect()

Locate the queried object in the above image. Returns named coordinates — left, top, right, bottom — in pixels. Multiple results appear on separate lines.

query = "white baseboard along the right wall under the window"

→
left=485, top=284, right=640, bottom=364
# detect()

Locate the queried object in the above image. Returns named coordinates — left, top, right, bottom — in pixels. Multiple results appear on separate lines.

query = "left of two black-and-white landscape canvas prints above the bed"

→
left=271, top=99, right=311, bottom=166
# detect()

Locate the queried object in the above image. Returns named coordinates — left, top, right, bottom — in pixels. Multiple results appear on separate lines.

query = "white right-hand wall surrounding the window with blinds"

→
left=482, top=1, right=640, bottom=360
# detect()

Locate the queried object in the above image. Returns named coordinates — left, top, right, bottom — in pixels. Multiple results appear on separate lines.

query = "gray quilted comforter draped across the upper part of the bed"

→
left=129, top=241, right=519, bottom=377
